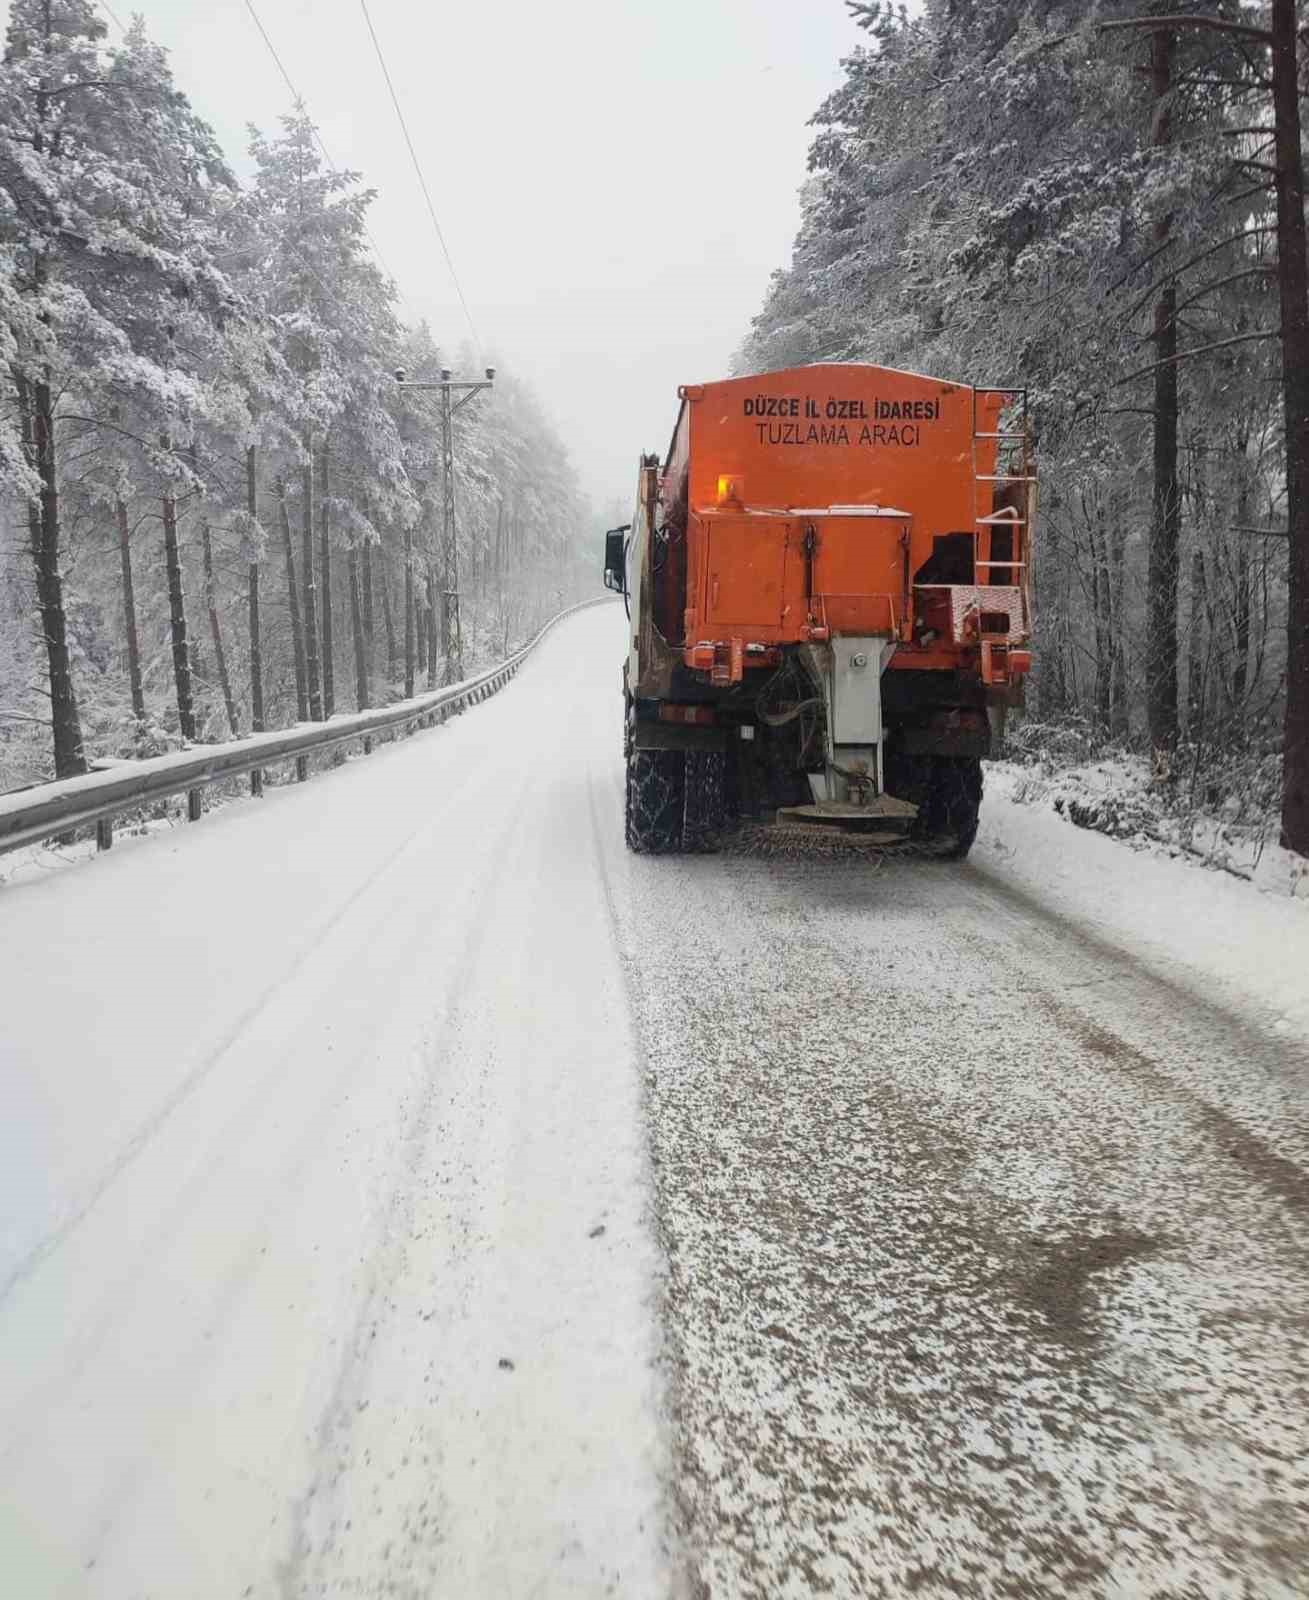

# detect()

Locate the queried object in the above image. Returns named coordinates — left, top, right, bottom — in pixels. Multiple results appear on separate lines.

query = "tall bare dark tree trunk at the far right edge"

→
left=1271, top=0, right=1309, bottom=856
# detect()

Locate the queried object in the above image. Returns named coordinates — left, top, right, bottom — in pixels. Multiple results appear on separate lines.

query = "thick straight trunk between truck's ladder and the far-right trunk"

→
left=1146, top=29, right=1181, bottom=749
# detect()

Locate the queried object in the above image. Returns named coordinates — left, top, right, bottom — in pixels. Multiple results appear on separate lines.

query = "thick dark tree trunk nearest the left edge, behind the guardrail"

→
left=14, top=373, right=86, bottom=778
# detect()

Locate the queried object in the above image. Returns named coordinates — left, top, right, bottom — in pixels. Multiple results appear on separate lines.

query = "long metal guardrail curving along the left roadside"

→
left=0, top=595, right=611, bottom=853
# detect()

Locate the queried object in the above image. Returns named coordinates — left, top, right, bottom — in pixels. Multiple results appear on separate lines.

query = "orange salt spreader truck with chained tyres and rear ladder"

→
left=605, top=363, right=1035, bottom=858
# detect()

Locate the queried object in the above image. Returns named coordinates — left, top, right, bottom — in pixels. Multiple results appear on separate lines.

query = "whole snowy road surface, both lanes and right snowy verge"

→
left=0, top=608, right=1309, bottom=1600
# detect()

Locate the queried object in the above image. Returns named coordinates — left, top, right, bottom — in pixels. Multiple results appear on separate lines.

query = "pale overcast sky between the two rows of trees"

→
left=58, top=0, right=861, bottom=507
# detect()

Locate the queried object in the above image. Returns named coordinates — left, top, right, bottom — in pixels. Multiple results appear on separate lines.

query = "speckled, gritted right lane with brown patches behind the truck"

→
left=595, top=780, right=1309, bottom=1600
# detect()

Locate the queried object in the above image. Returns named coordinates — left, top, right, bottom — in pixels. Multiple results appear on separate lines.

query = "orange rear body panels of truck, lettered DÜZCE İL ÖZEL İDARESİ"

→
left=664, top=365, right=1002, bottom=648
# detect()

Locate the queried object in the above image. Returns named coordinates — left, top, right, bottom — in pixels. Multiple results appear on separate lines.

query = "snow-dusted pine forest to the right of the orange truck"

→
left=736, top=0, right=1309, bottom=854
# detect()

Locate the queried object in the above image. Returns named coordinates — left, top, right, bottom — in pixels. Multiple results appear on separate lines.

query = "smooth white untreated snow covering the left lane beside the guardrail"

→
left=0, top=604, right=666, bottom=1600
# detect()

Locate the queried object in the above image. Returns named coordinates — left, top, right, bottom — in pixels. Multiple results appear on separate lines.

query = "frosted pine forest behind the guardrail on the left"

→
left=0, top=0, right=595, bottom=790
